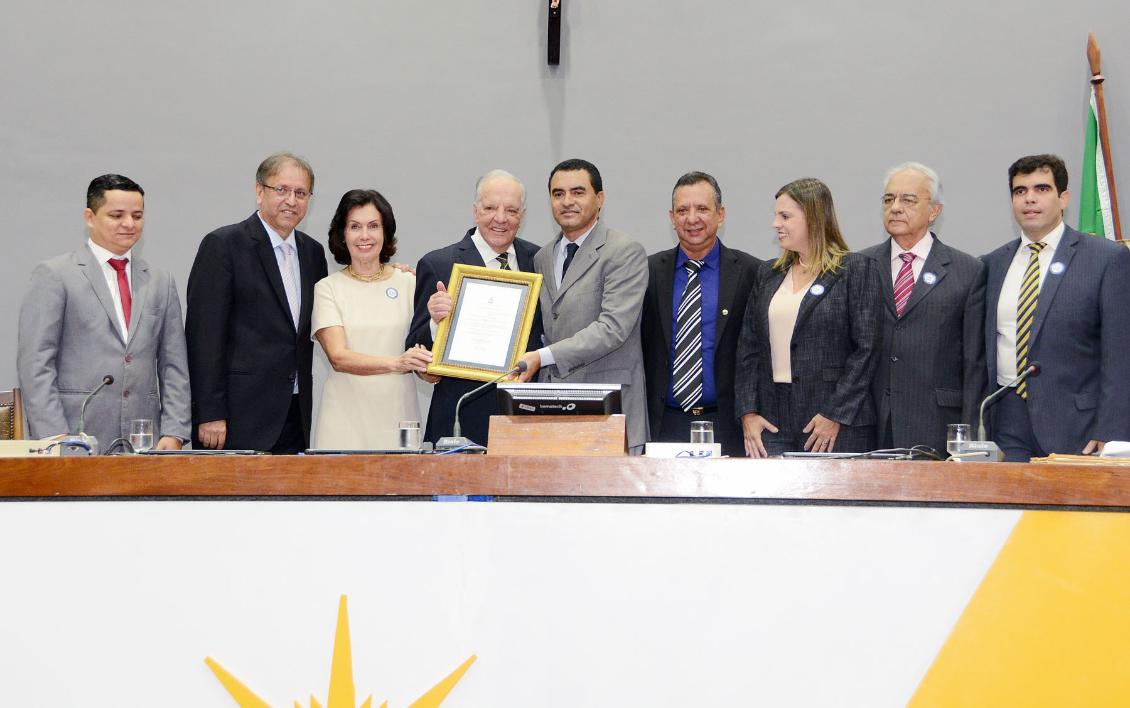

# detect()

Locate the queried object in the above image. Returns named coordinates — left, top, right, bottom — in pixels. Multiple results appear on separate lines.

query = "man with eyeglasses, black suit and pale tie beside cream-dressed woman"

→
left=185, top=152, right=327, bottom=454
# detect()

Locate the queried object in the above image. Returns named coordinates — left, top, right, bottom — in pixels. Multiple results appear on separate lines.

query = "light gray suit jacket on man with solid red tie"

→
left=16, top=246, right=191, bottom=452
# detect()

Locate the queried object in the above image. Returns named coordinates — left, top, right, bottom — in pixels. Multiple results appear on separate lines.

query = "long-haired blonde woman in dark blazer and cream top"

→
left=736, top=177, right=883, bottom=457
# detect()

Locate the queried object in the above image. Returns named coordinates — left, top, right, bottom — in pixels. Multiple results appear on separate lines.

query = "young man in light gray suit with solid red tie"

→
left=16, top=175, right=190, bottom=451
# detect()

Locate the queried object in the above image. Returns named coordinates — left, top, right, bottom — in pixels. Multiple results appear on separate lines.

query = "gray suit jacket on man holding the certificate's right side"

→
left=533, top=220, right=647, bottom=452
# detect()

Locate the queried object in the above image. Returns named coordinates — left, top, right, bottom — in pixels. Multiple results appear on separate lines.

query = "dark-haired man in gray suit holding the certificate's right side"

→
left=521, top=159, right=647, bottom=454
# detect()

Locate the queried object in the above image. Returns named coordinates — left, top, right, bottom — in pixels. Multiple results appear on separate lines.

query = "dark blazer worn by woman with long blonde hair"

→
left=736, top=253, right=883, bottom=432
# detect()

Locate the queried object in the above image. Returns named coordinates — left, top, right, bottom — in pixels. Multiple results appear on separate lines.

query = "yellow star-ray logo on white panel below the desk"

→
left=205, top=595, right=477, bottom=708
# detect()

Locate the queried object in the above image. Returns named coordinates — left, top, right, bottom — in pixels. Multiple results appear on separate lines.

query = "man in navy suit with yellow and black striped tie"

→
left=982, top=155, right=1130, bottom=462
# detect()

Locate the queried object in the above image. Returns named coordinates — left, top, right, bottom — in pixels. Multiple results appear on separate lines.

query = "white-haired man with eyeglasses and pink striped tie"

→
left=863, top=163, right=985, bottom=451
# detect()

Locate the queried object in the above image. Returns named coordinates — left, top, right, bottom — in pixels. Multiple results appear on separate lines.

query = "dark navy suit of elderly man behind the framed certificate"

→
left=405, top=228, right=541, bottom=445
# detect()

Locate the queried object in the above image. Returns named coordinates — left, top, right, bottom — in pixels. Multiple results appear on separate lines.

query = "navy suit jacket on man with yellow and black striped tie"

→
left=982, top=227, right=1130, bottom=454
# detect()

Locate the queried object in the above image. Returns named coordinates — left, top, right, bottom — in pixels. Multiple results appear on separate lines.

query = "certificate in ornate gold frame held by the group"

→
left=427, top=263, right=541, bottom=381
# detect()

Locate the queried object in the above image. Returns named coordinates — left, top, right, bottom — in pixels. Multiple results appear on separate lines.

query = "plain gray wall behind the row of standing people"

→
left=0, top=0, right=1130, bottom=415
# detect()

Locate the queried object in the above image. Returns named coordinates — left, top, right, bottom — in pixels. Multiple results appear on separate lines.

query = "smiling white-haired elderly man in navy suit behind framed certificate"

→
left=405, top=169, right=541, bottom=445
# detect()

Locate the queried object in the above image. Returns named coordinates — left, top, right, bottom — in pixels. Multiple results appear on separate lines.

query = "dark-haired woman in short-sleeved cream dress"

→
left=311, top=190, right=432, bottom=449
